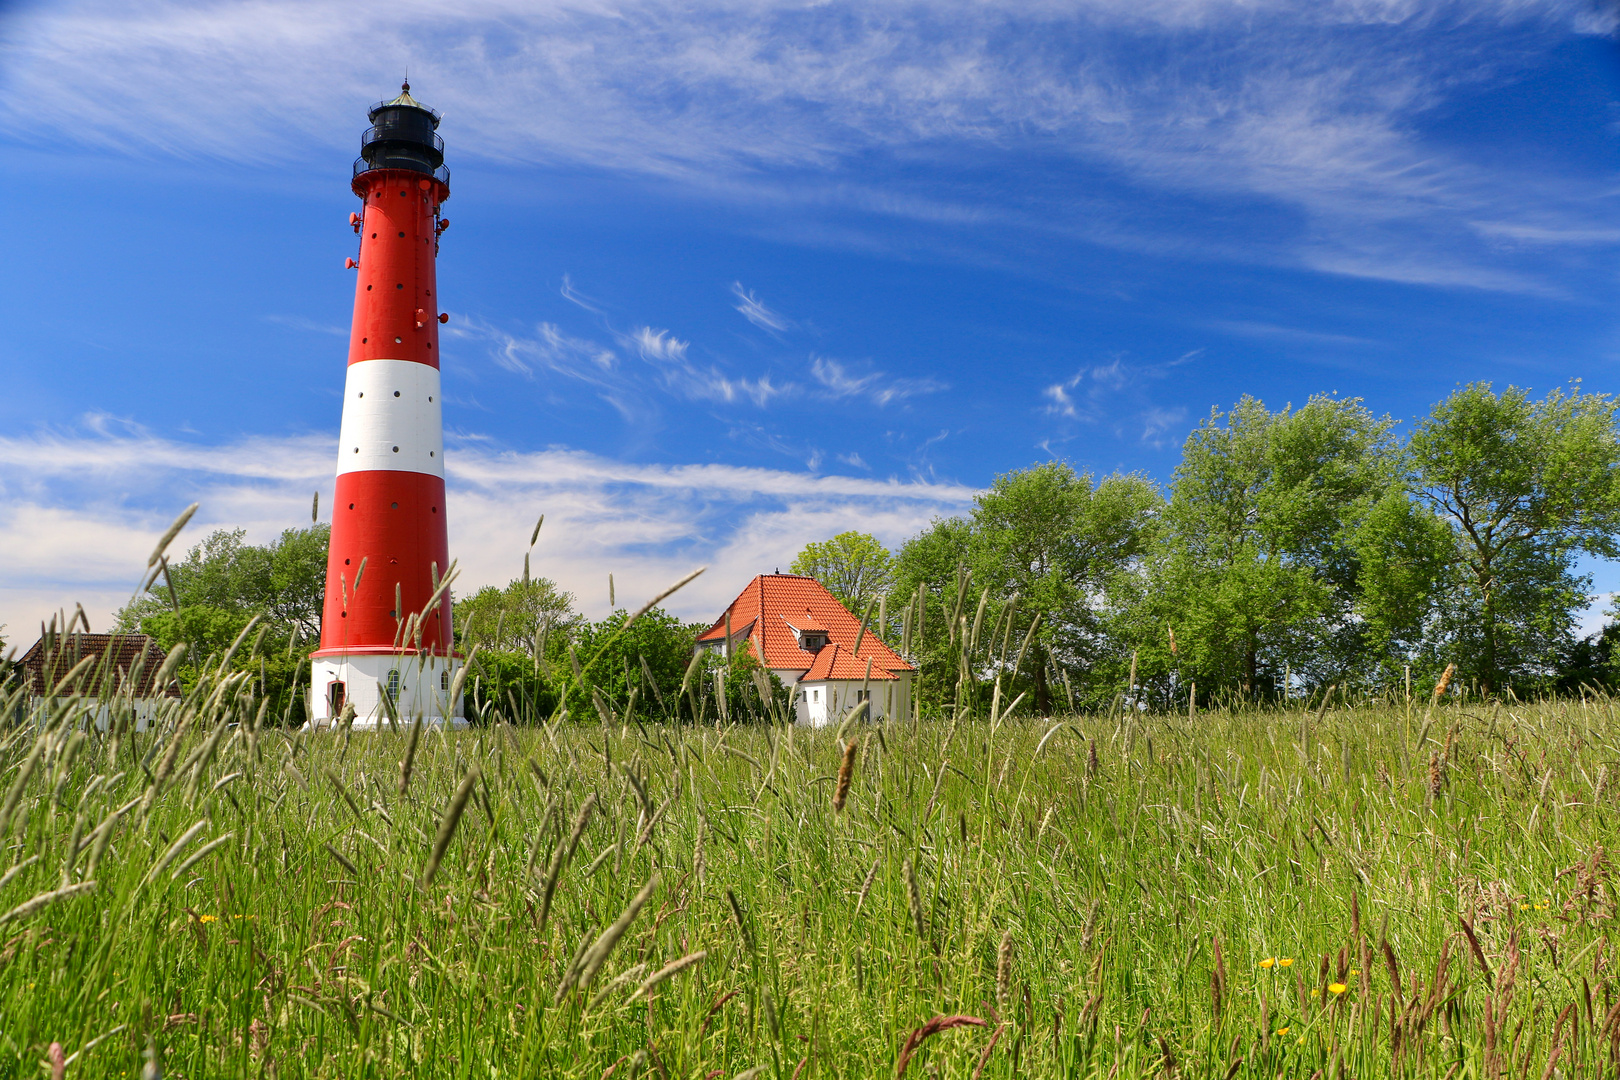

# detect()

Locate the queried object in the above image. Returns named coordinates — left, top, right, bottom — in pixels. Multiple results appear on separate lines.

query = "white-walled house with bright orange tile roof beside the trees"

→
left=698, top=573, right=917, bottom=727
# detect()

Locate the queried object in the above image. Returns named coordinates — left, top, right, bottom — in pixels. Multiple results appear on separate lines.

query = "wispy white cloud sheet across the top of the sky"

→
left=0, top=0, right=1614, bottom=293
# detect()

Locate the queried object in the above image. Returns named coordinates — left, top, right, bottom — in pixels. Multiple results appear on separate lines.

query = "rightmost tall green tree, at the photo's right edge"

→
left=1409, top=382, right=1620, bottom=693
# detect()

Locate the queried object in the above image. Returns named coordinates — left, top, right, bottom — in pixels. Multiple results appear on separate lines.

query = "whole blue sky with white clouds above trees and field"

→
left=0, top=0, right=1620, bottom=641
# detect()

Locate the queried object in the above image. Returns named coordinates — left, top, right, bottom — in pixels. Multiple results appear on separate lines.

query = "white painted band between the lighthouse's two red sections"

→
left=337, top=359, right=444, bottom=478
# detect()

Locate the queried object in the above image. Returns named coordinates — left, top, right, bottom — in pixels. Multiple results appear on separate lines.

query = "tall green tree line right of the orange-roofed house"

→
left=822, top=384, right=1620, bottom=714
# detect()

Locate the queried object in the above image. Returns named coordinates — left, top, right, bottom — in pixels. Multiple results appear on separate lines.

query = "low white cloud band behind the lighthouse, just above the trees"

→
left=0, top=427, right=974, bottom=646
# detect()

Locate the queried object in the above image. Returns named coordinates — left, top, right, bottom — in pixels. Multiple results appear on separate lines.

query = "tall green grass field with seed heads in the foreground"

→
left=0, top=654, right=1620, bottom=1080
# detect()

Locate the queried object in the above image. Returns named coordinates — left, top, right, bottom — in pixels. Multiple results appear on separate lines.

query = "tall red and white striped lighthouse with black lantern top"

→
left=309, top=83, right=463, bottom=729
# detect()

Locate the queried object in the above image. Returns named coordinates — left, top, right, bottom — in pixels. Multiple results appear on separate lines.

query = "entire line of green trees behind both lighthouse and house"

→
left=101, top=384, right=1620, bottom=721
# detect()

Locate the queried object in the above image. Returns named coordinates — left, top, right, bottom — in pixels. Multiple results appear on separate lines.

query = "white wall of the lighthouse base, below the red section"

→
left=309, top=653, right=467, bottom=730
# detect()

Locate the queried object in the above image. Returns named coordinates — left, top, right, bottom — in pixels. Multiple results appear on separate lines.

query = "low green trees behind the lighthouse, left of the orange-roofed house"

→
left=115, top=525, right=781, bottom=724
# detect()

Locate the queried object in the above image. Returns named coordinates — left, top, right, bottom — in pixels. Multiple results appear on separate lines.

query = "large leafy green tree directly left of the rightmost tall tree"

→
left=1139, top=397, right=1395, bottom=698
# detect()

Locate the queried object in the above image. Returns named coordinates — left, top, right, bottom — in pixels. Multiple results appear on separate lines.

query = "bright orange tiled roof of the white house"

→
left=698, top=573, right=914, bottom=678
